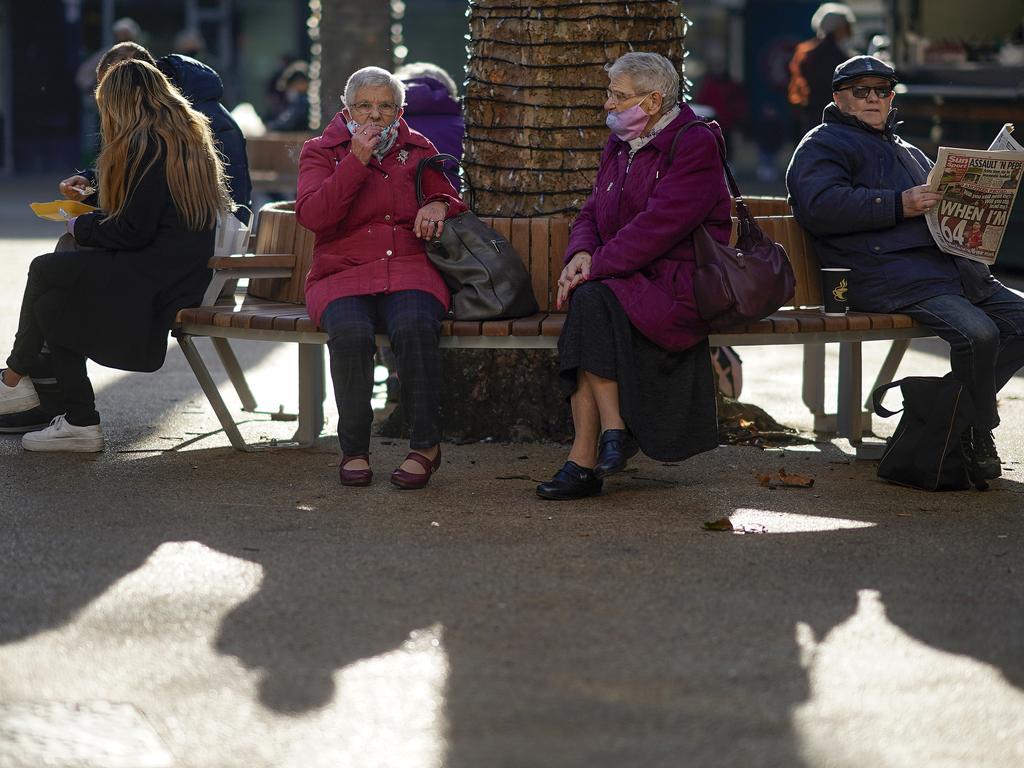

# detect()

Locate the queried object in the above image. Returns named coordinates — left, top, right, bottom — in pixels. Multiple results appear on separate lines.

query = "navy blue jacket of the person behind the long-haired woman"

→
left=157, top=53, right=252, bottom=218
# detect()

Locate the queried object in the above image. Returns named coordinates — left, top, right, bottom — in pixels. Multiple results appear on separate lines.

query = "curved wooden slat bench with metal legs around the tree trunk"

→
left=174, top=203, right=933, bottom=460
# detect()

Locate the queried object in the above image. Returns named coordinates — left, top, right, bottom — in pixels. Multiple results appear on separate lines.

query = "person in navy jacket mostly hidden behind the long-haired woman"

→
left=0, top=41, right=252, bottom=434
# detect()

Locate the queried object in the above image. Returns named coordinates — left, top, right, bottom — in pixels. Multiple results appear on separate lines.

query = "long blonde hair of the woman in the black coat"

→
left=96, top=59, right=234, bottom=231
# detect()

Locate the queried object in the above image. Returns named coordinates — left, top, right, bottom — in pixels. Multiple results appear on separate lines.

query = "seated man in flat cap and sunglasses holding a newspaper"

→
left=785, top=56, right=1024, bottom=478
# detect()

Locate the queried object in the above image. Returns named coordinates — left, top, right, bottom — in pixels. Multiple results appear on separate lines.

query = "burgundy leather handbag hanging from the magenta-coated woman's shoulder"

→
left=669, top=120, right=797, bottom=330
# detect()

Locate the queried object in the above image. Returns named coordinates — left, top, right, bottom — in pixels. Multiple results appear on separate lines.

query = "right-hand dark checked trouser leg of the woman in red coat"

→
left=383, top=291, right=444, bottom=450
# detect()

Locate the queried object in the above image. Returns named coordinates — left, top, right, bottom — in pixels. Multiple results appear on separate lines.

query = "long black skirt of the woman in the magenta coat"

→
left=558, top=282, right=718, bottom=461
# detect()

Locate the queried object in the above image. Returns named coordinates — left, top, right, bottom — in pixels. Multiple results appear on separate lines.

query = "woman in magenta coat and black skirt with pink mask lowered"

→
left=537, top=53, right=731, bottom=500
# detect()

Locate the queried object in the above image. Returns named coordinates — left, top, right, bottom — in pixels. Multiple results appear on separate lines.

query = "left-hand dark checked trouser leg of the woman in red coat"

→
left=321, top=296, right=376, bottom=456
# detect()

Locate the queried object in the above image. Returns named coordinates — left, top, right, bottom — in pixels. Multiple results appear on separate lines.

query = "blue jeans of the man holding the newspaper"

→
left=899, top=287, right=1024, bottom=430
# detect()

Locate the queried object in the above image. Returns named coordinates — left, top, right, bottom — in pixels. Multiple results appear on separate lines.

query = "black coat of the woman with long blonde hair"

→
left=46, top=146, right=214, bottom=371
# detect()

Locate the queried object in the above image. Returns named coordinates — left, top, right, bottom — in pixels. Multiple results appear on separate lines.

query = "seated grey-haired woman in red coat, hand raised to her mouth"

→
left=295, top=67, right=466, bottom=488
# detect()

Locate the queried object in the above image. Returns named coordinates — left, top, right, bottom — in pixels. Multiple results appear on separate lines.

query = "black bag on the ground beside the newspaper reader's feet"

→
left=871, top=376, right=988, bottom=490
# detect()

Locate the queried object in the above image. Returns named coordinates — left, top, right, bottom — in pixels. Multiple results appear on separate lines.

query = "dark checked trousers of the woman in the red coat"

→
left=321, top=291, right=444, bottom=456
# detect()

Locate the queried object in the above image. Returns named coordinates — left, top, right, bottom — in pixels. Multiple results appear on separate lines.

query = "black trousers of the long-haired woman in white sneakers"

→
left=7, top=251, right=99, bottom=427
